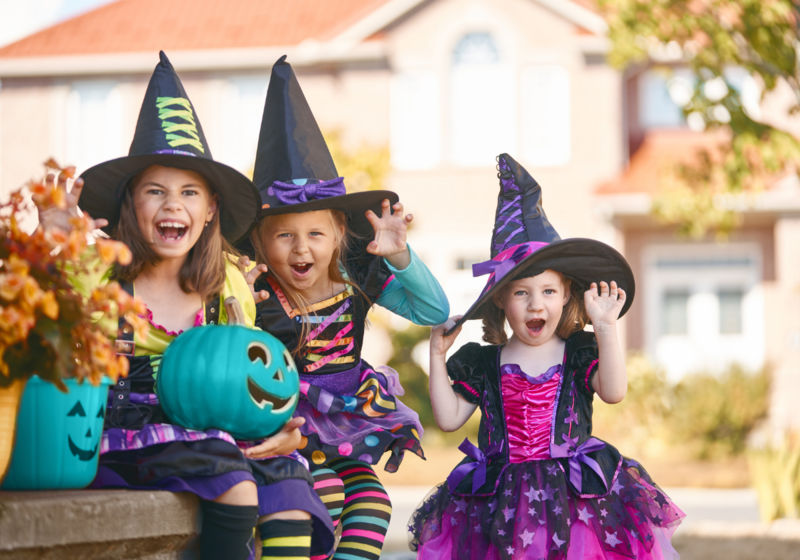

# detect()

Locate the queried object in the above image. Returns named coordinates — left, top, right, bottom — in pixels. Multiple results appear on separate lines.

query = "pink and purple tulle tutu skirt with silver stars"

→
left=409, top=459, right=685, bottom=560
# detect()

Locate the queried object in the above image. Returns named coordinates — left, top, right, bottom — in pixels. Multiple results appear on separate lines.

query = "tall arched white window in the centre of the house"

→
left=449, top=33, right=517, bottom=166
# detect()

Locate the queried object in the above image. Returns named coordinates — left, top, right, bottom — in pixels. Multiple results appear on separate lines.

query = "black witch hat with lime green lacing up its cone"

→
left=78, top=51, right=259, bottom=243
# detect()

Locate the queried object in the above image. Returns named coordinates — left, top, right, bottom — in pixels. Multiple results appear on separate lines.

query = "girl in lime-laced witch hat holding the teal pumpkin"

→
left=34, top=52, right=333, bottom=560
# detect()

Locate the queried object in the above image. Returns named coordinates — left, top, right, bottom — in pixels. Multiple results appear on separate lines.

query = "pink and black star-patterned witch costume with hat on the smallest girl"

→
left=409, top=154, right=684, bottom=560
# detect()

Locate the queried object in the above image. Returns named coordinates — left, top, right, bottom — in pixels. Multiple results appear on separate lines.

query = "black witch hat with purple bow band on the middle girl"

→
left=244, top=55, right=398, bottom=245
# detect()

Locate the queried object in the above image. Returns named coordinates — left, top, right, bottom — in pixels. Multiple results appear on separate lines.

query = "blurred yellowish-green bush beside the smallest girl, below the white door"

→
left=593, top=354, right=769, bottom=459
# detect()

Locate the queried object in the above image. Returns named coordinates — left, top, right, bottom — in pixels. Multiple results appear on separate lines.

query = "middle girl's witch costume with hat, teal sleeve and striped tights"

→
left=244, top=57, right=449, bottom=558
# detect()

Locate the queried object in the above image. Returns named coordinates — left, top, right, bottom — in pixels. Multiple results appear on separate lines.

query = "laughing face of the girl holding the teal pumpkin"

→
left=133, top=165, right=217, bottom=259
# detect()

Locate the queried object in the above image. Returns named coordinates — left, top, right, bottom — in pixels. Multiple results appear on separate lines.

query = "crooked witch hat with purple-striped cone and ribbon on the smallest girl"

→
left=447, top=154, right=636, bottom=334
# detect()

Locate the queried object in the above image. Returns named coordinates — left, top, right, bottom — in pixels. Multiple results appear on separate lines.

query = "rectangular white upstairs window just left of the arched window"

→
left=391, top=71, right=442, bottom=169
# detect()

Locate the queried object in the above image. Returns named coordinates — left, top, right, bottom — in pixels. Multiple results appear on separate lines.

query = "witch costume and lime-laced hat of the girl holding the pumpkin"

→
left=73, top=52, right=333, bottom=558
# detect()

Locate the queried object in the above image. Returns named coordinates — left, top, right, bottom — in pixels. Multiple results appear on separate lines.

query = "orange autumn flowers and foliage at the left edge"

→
left=0, top=160, right=148, bottom=391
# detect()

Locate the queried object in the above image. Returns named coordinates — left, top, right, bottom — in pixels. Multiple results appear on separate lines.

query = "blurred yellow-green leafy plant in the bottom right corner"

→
left=747, top=434, right=800, bottom=522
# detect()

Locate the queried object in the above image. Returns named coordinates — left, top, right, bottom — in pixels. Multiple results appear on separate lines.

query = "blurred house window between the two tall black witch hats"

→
left=219, top=76, right=269, bottom=176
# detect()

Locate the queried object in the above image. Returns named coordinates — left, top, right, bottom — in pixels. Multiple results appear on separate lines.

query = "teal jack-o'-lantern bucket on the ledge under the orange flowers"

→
left=2, top=375, right=111, bottom=490
